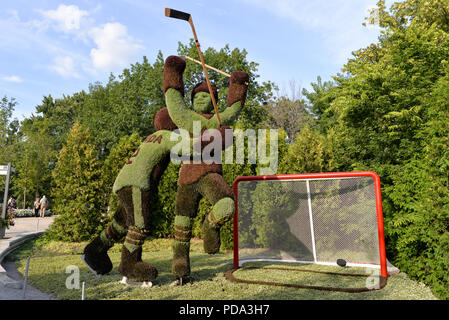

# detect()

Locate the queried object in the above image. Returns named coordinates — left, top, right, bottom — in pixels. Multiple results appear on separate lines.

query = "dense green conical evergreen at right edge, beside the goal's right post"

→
left=387, top=73, right=449, bottom=299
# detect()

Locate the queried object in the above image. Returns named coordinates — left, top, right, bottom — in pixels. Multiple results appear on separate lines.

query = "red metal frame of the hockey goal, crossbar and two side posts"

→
left=232, top=171, right=388, bottom=278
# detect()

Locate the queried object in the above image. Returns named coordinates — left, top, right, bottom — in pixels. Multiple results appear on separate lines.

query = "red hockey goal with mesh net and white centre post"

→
left=233, top=171, right=394, bottom=278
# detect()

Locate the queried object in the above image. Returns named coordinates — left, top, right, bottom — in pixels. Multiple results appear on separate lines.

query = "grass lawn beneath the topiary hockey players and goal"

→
left=8, top=239, right=436, bottom=300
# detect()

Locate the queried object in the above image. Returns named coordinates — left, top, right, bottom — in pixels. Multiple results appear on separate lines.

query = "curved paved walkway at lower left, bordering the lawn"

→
left=0, top=216, right=54, bottom=300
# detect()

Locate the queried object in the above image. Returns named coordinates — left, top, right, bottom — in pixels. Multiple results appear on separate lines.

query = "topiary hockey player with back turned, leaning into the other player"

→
left=82, top=108, right=213, bottom=282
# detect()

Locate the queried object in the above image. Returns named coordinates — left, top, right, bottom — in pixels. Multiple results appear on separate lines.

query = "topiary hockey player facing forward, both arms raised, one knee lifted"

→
left=163, top=56, right=249, bottom=284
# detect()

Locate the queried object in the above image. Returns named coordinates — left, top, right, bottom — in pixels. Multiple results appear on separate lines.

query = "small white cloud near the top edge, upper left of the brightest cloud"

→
left=41, top=4, right=89, bottom=33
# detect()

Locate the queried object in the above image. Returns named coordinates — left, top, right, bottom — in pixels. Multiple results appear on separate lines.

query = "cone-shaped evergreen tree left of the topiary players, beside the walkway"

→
left=50, top=122, right=107, bottom=242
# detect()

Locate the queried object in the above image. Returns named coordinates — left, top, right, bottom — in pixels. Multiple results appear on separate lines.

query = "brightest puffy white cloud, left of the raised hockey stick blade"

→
left=89, top=22, right=143, bottom=71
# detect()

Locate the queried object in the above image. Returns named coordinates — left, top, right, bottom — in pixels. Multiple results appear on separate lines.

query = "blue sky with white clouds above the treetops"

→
left=0, top=0, right=391, bottom=120
